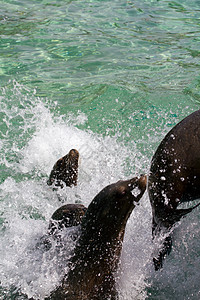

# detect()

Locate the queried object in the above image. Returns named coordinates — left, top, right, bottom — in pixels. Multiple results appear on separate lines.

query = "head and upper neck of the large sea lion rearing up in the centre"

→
left=82, top=175, right=147, bottom=237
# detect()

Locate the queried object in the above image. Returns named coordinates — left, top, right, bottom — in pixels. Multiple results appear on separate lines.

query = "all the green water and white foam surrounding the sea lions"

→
left=0, top=0, right=200, bottom=300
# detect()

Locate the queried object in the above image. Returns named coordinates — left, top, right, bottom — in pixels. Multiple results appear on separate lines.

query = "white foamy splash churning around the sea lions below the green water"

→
left=0, top=82, right=200, bottom=300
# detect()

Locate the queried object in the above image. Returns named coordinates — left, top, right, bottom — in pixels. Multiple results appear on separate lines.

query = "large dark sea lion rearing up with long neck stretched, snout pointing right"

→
left=48, top=176, right=146, bottom=300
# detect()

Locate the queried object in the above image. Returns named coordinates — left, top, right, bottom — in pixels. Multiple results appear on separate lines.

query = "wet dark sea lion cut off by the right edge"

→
left=148, top=110, right=200, bottom=270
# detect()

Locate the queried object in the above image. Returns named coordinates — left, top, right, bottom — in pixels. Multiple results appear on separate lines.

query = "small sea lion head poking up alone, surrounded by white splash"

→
left=47, top=149, right=79, bottom=188
